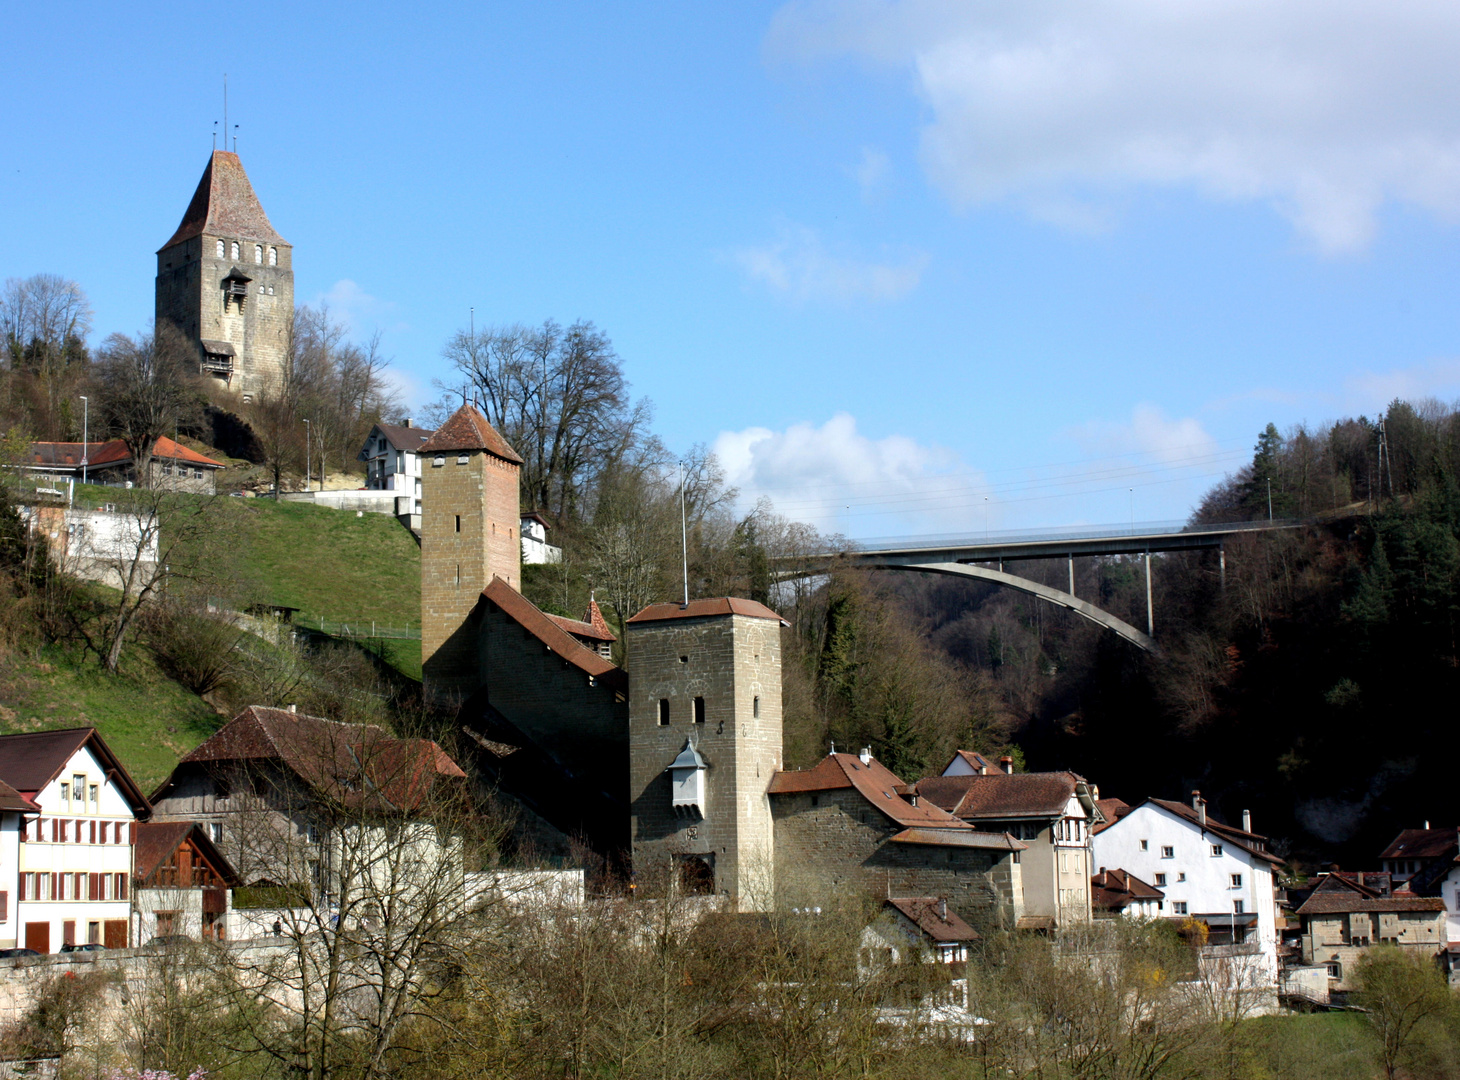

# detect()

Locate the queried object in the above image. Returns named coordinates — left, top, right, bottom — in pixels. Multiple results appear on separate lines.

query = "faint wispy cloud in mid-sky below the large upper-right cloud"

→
left=734, top=228, right=927, bottom=304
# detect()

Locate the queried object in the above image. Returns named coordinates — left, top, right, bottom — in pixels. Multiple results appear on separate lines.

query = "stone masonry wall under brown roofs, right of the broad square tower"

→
left=771, top=788, right=1022, bottom=930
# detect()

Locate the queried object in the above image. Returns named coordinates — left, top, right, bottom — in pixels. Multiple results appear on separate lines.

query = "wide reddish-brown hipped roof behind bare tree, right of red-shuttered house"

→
left=153, top=705, right=466, bottom=810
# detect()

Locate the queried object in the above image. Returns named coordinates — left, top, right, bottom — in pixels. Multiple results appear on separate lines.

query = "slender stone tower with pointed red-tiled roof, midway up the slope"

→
left=419, top=406, right=523, bottom=703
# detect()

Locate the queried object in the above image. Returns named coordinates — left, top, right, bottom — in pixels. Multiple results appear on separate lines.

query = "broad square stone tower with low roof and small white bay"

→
left=625, top=598, right=781, bottom=911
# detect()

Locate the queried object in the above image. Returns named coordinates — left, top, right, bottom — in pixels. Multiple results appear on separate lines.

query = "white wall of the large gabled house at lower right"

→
left=1094, top=803, right=1278, bottom=979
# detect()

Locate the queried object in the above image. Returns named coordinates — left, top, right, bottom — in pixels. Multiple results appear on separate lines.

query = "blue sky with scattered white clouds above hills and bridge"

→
left=8, top=0, right=1460, bottom=537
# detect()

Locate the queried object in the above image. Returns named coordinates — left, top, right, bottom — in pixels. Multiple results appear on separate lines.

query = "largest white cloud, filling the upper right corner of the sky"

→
left=767, top=0, right=1460, bottom=252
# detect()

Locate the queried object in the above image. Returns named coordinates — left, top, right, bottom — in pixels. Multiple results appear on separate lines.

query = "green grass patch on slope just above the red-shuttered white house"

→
left=0, top=648, right=223, bottom=792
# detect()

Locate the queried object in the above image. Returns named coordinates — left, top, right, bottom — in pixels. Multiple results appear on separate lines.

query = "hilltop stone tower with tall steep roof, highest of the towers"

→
left=156, top=150, right=293, bottom=401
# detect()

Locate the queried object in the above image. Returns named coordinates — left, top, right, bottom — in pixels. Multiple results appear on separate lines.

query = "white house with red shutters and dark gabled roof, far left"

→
left=0, top=728, right=152, bottom=953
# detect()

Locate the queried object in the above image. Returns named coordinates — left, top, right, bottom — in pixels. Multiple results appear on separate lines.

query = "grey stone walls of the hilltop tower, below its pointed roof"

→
left=156, top=234, right=293, bottom=398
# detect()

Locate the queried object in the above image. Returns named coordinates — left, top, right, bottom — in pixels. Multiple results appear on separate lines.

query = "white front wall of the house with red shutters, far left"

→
left=15, top=746, right=134, bottom=953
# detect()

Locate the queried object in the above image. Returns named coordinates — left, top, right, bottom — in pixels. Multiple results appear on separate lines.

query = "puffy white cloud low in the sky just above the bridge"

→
left=714, top=413, right=987, bottom=537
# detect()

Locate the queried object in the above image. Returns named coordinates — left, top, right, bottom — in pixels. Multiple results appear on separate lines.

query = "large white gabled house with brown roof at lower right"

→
left=1092, top=791, right=1282, bottom=982
